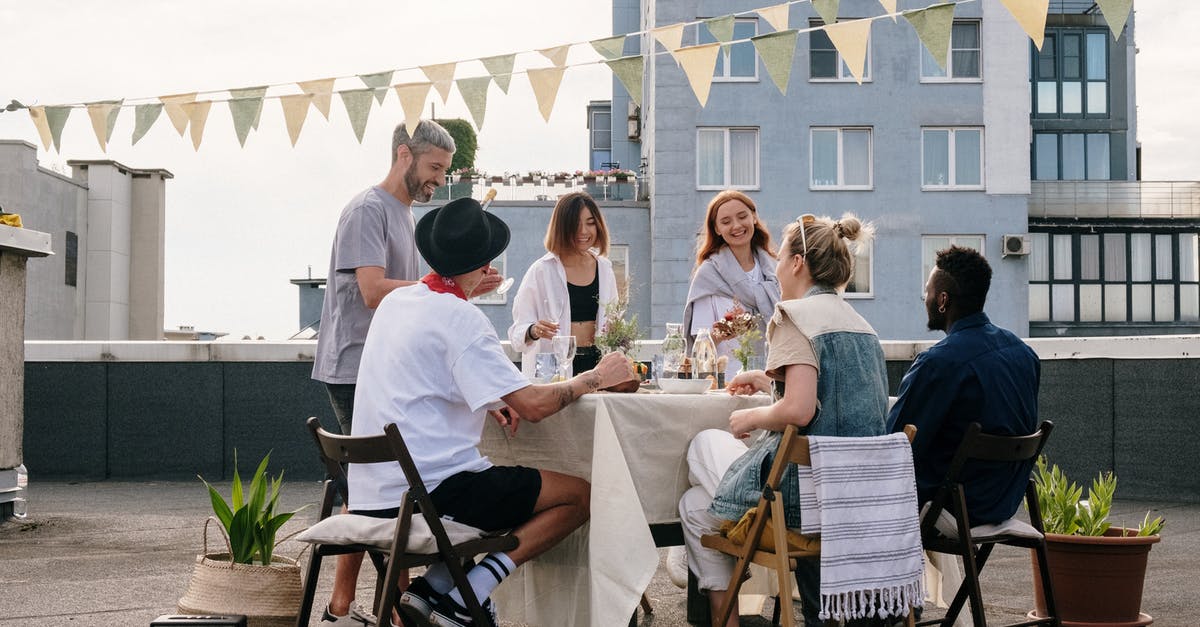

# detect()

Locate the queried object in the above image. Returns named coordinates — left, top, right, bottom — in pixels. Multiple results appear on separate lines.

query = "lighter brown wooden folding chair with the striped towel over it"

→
left=700, top=425, right=917, bottom=627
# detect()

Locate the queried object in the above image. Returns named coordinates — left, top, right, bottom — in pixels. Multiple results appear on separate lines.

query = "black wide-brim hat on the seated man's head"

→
left=416, top=198, right=510, bottom=276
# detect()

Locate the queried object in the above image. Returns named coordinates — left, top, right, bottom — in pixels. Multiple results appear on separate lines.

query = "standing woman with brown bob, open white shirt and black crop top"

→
left=509, top=192, right=617, bottom=377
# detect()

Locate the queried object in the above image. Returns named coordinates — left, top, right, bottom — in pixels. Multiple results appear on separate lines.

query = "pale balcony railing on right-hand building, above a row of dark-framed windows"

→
left=1030, top=180, right=1200, bottom=220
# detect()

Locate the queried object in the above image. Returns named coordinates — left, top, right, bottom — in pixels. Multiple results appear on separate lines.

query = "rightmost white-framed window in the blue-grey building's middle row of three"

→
left=920, top=129, right=983, bottom=190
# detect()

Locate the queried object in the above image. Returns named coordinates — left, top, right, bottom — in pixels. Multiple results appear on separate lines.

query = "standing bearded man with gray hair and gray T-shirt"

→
left=312, top=120, right=500, bottom=627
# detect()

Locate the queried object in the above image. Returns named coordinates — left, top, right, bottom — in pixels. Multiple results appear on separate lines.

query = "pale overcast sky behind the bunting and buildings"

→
left=0, top=0, right=1200, bottom=339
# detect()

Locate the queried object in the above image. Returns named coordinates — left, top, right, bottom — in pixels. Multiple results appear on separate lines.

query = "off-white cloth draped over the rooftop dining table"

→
left=481, top=393, right=770, bottom=627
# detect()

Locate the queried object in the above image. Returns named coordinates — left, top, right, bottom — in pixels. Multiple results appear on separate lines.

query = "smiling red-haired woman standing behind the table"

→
left=683, top=190, right=779, bottom=380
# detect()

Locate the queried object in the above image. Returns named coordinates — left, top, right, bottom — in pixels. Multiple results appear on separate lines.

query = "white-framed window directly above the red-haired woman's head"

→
left=696, top=129, right=758, bottom=190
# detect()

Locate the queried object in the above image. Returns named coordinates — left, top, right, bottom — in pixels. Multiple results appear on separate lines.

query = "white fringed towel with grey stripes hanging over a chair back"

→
left=799, top=434, right=925, bottom=620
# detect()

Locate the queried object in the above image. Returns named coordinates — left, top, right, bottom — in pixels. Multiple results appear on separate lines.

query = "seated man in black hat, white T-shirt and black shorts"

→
left=349, top=198, right=634, bottom=627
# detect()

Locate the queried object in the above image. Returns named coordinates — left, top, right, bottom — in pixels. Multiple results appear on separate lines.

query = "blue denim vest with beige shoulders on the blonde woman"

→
left=708, top=287, right=888, bottom=529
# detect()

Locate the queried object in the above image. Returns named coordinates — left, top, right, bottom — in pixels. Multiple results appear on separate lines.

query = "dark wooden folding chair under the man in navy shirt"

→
left=918, top=420, right=1061, bottom=627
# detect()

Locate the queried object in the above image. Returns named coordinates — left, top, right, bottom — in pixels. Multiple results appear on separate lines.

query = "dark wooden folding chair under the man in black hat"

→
left=296, top=418, right=517, bottom=627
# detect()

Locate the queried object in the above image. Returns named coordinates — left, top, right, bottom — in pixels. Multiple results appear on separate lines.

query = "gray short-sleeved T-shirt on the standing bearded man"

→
left=312, top=186, right=418, bottom=383
